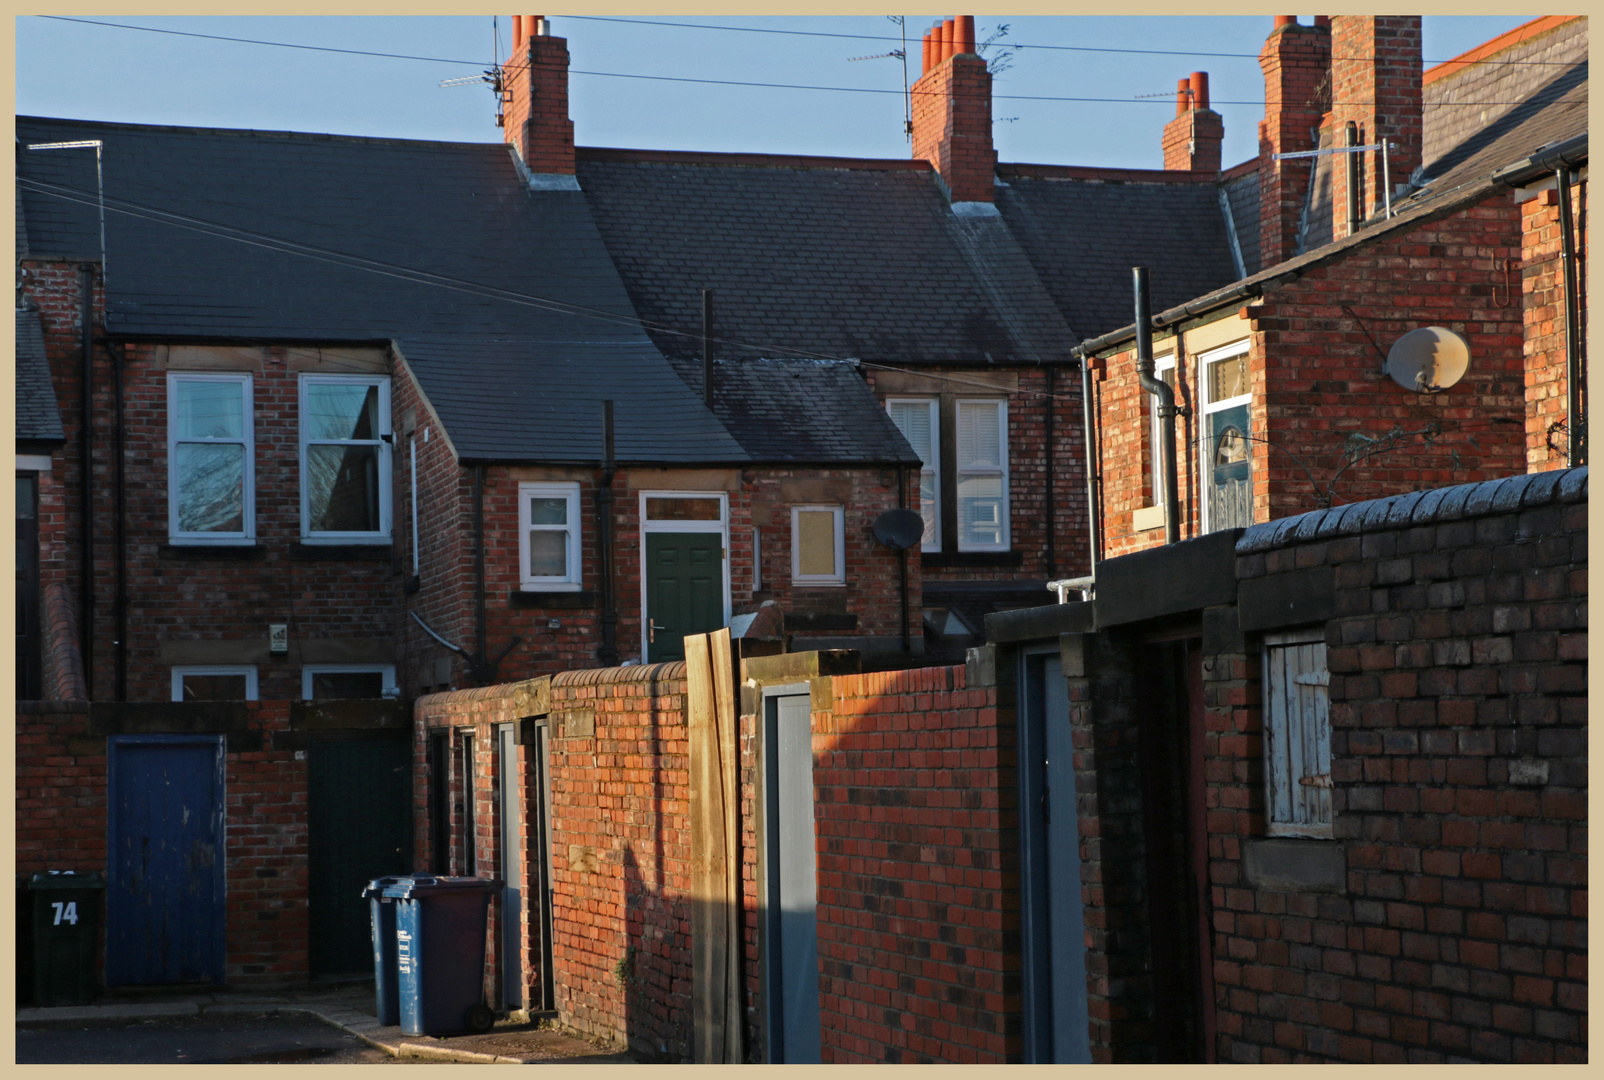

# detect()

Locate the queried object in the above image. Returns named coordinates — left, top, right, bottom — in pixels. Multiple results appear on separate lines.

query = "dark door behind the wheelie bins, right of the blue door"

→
left=306, top=737, right=412, bottom=974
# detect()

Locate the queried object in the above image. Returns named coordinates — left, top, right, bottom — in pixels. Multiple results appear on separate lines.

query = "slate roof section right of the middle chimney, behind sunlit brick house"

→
left=998, top=167, right=1237, bottom=337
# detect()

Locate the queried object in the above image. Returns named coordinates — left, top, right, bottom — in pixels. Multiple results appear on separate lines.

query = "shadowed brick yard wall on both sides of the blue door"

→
left=14, top=701, right=308, bottom=985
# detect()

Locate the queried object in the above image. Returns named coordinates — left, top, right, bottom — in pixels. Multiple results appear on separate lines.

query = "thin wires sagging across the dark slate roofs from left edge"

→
left=18, top=177, right=1079, bottom=401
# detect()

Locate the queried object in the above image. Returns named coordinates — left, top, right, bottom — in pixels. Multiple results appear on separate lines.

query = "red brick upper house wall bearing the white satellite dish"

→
left=1097, top=197, right=1525, bottom=557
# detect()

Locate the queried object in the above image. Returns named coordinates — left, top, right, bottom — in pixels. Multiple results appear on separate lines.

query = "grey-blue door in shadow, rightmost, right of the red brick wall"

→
left=1020, top=653, right=1091, bottom=1064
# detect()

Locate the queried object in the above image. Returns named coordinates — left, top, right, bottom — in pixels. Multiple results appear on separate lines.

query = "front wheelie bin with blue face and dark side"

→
left=383, top=875, right=502, bottom=1035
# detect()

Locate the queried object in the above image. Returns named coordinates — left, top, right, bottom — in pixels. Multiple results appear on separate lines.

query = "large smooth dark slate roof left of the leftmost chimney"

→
left=18, top=117, right=769, bottom=464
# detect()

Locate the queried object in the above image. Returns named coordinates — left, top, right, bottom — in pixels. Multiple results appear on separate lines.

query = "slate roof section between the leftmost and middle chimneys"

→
left=577, top=149, right=1071, bottom=364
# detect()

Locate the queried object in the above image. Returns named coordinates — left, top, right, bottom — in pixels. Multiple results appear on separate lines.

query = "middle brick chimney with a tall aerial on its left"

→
left=913, top=14, right=998, bottom=202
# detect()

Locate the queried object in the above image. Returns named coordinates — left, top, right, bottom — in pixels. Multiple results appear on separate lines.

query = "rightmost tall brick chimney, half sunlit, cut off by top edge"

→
left=1325, top=14, right=1421, bottom=238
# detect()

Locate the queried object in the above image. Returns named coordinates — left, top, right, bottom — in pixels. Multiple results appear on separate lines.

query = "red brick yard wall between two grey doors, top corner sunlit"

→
left=813, top=668, right=1020, bottom=1062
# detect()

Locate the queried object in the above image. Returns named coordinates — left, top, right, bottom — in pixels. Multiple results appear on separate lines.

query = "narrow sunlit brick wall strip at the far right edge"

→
left=1521, top=183, right=1588, bottom=472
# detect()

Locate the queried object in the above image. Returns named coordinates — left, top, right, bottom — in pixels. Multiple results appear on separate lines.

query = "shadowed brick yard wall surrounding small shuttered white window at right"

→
left=1205, top=470, right=1586, bottom=1062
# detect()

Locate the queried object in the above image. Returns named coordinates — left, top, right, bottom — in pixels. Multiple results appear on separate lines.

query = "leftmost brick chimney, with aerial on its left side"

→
left=502, top=14, right=574, bottom=177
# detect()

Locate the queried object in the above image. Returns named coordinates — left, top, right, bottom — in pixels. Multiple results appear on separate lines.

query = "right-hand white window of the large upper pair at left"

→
left=300, top=374, right=390, bottom=544
